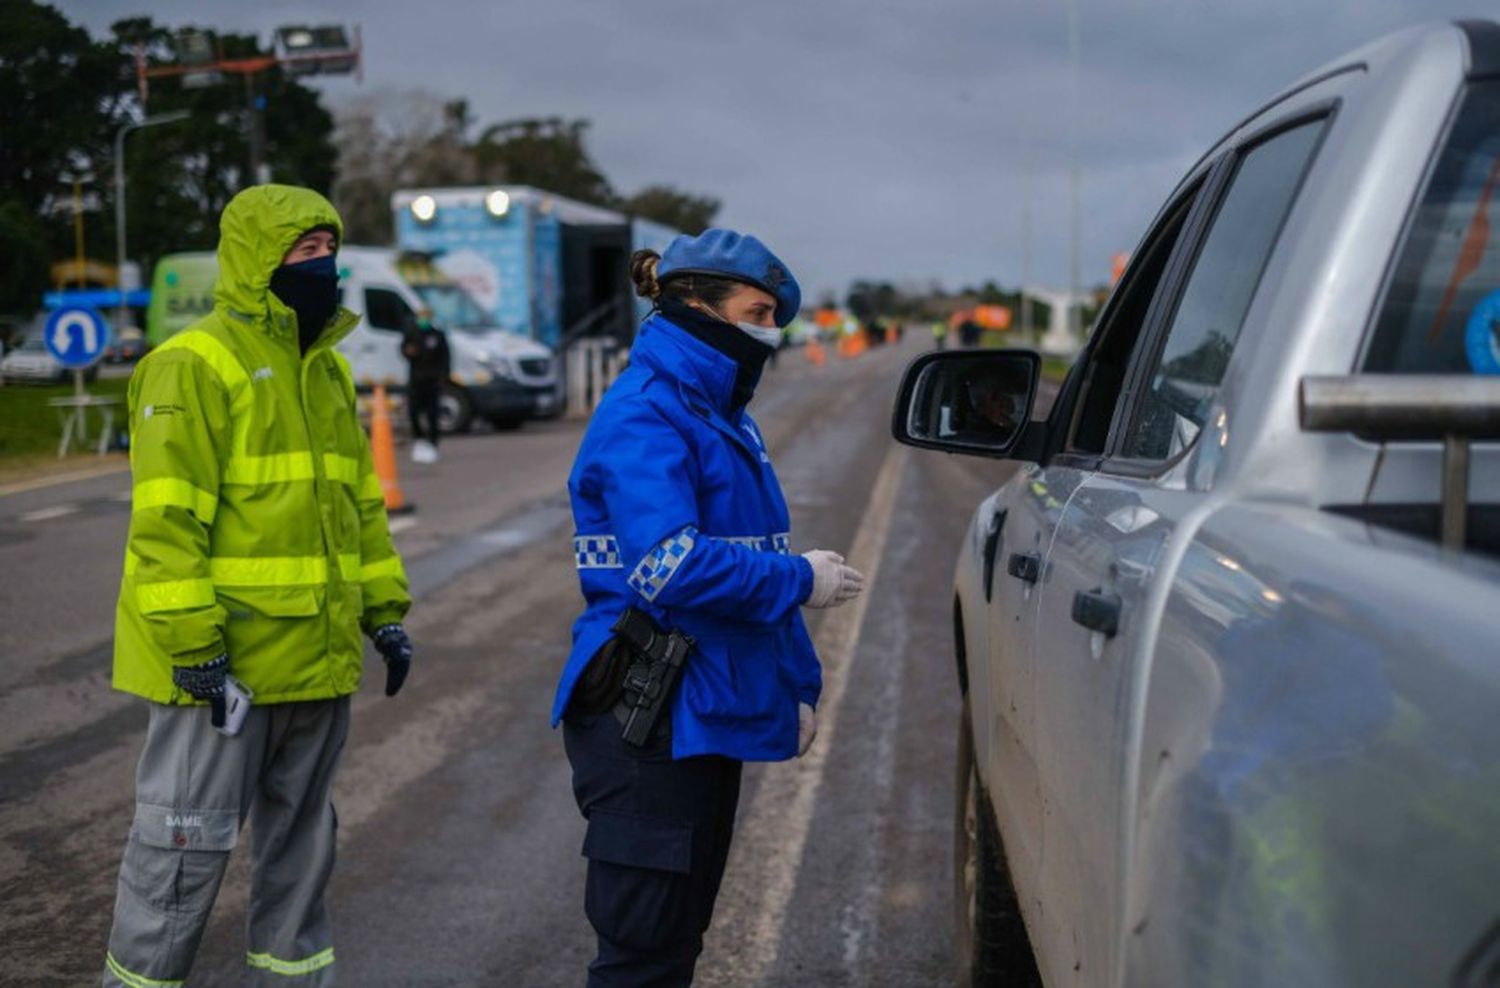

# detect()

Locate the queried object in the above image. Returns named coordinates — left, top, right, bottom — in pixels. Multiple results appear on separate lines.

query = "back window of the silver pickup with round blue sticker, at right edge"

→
left=1364, top=82, right=1500, bottom=373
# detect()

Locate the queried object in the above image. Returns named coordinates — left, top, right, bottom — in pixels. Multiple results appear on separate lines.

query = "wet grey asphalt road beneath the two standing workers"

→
left=0, top=339, right=1008, bottom=987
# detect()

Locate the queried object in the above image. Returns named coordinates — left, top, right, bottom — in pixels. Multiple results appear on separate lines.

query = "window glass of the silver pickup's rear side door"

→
left=1121, top=120, right=1325, bottom=460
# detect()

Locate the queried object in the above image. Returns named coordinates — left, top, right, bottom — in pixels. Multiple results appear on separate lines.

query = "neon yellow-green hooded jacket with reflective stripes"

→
left=114, top=186, right=411, bottom=703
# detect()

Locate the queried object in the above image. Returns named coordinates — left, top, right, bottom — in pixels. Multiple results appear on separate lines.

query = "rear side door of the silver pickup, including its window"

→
left=1035, top=118, right=1325, bottom=984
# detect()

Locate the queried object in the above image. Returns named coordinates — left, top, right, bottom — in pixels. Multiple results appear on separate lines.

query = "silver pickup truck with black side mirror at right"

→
left=893, top=22, right=1500, bottom=988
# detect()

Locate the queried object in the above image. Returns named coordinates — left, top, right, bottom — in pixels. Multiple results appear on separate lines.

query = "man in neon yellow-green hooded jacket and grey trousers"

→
left=104, top=186, right=411, bottom=988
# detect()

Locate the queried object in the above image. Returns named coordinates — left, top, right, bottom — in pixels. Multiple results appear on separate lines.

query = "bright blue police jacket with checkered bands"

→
left=552, top=315, right=822, bottom=762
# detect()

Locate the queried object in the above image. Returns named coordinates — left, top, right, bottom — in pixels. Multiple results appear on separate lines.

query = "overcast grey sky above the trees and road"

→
left=59, top=0, right=1497, bottom=301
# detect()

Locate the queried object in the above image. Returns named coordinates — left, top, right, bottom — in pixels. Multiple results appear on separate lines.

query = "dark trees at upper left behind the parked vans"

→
left=0, top=0, right=720, bottom=315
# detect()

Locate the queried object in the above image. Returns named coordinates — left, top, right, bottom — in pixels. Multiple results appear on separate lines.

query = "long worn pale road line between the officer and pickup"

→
left=726, top=444, right=906, bottom=985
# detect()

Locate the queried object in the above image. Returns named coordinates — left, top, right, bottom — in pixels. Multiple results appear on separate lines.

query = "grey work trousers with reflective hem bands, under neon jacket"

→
left=104, top=697, right=350, bottom=988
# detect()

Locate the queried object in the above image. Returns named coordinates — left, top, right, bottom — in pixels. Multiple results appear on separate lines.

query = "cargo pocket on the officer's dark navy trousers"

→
left=584, top=808, right=698, bottom=951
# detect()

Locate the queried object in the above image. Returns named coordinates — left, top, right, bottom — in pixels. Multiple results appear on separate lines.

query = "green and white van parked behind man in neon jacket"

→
left=147, top=246, right=563, bottom=432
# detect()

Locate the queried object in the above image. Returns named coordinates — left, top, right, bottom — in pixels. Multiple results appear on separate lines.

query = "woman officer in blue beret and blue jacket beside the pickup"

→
left=552, top=229, right=864, bottom=987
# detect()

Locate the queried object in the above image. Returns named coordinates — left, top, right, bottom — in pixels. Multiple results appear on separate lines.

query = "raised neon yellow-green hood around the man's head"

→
left=213, top=184, right=344, bottom=319
